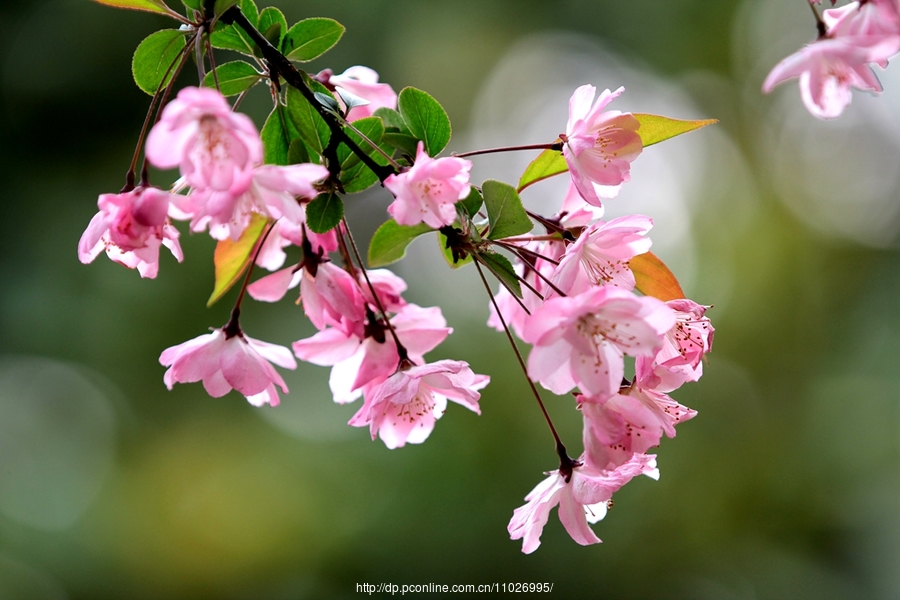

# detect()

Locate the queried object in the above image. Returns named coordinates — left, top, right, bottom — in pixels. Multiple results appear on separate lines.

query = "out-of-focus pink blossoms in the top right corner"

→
left=763, top=0, right=900, bottom=119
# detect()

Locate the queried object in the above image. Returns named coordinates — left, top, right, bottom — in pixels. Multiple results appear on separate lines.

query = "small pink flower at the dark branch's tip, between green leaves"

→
left=384, top=142, right=472, bottom=229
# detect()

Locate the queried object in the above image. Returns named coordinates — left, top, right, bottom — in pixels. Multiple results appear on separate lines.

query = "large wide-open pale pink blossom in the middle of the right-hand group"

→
left=522, top=286, right=675, bottom=396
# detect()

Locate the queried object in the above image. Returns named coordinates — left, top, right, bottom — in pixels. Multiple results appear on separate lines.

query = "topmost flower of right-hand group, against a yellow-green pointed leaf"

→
left=563, top=85, right=644, bottom=206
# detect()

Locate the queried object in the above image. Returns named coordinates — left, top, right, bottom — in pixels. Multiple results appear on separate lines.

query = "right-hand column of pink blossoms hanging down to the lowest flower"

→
left=488, top=86, right=713, bottom=553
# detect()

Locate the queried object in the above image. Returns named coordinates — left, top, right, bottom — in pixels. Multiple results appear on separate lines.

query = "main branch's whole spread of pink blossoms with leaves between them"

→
left=78, top=0, right=713, bottom=553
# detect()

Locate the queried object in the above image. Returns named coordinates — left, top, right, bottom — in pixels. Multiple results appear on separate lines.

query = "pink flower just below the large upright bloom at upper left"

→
left=182, top=163, right=328, bottom=240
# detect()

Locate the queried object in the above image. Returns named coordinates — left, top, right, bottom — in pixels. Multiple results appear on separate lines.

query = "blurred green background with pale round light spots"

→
left=0, top=0, right=900, bottom=600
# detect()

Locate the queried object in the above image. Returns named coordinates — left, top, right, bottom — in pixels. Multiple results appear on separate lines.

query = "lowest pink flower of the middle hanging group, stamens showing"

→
left=350, top=360, right=491, bottom=449
